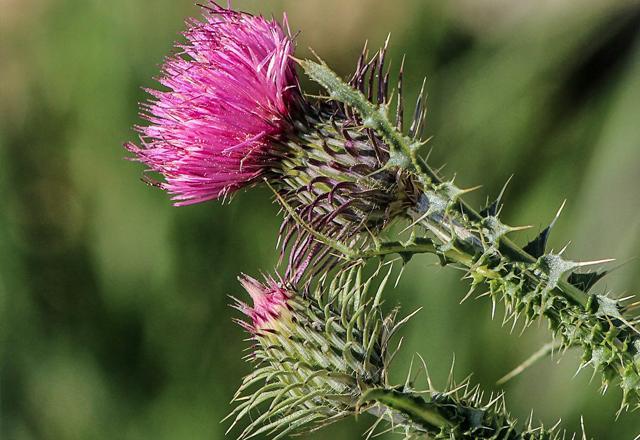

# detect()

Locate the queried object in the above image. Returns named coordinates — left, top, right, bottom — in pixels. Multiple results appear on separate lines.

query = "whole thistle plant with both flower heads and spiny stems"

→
left=125, top=3, right=640, bottom=439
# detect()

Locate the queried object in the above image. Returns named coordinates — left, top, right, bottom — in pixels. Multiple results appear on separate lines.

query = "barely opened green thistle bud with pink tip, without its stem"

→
left=225, top=270, right=396, bottom=438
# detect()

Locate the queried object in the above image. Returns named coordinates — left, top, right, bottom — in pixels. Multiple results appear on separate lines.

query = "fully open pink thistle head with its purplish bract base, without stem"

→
left=125, top=3, right=419, bottom=281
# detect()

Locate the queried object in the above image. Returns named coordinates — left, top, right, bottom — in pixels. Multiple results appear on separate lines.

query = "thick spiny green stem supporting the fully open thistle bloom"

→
left=300, top=55, right=640, bottom=409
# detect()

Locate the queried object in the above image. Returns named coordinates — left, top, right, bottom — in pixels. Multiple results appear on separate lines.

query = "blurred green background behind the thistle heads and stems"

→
left=0, top=0, right=640, bottom=440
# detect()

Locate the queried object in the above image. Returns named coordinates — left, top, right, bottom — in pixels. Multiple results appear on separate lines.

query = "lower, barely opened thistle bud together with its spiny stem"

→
left=229, top=266, right=576, bottom=439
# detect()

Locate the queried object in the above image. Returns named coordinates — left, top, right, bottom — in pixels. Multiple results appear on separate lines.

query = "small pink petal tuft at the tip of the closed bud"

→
left=236, top=274, right=292, bottom=333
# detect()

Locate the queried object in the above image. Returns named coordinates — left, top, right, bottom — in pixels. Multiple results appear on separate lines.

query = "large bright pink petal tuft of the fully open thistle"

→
left=125, top=3, right=300, bottom=206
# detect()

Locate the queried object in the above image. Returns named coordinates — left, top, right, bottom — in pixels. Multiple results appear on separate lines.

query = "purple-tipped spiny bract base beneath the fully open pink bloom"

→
left=273, top=45, right=424, bottom=281
